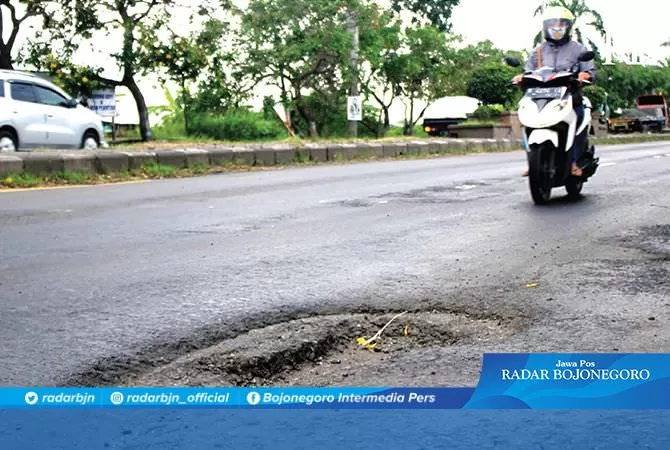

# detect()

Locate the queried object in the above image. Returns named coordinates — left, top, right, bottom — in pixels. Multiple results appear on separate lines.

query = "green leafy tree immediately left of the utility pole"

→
left=240, top=0, right=352, bottom=137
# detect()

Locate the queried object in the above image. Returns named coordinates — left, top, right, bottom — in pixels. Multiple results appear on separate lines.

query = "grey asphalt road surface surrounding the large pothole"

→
left=0, top=143, right=670, bottom=385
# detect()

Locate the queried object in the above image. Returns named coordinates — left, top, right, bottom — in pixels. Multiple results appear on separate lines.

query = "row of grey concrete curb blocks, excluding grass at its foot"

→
left=0, top=135, right=670, bottom=176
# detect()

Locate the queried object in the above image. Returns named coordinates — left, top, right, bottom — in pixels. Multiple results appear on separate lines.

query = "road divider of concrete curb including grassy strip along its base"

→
left=0, top=134, right=670, bottom=188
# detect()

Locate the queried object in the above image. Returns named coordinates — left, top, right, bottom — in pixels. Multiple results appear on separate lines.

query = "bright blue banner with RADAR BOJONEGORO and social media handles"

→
left=0, top=353, right=670, bottom=410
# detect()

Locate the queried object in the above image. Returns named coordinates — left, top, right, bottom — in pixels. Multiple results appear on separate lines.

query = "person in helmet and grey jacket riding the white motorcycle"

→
left=513, top=6, right=596, bottom=176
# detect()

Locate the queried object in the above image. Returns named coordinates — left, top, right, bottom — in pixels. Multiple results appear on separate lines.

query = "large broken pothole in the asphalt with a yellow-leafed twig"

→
left=120, top=311, right=521, bottom=386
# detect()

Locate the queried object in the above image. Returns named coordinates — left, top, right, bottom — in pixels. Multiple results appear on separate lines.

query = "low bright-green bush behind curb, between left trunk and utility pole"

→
left=189, top=110, right=286, bottom=141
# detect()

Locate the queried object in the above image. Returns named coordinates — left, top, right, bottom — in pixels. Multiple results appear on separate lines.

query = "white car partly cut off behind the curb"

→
left=0, top=70, right=107, bottom=152
